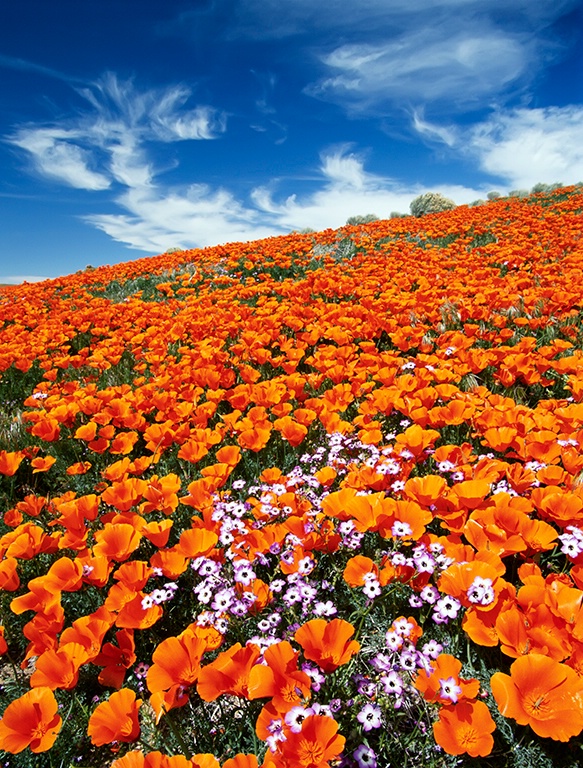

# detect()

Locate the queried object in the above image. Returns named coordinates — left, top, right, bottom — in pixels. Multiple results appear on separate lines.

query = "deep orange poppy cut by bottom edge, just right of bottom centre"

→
left=280, top=715, right=346, bottom=768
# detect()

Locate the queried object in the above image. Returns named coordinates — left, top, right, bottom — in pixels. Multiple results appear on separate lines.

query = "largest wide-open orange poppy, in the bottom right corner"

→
left=490, top=653, right=583, bottom=741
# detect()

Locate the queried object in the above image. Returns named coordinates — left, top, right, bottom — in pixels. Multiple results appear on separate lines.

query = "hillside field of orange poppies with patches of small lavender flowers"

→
left=0, top=187, right=583, bottom=768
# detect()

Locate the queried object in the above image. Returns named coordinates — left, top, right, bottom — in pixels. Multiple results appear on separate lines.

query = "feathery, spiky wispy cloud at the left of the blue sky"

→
left=5, top=73, right=226, bottom=191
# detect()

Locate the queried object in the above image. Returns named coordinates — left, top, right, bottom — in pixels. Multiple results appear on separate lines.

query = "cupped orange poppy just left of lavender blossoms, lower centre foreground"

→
left=294, top=619, right=360, bottom=672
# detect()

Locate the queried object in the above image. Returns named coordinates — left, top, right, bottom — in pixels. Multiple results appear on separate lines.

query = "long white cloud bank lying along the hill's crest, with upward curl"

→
left=78, top=145, right=485, bottom=253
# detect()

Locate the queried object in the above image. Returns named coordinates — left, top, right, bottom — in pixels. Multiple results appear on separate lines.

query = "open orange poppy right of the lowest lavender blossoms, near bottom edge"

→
left=433, top=701, right=496, bottom=757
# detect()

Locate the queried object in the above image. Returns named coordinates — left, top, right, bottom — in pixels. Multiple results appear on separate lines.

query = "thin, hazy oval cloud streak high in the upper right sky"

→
left=306, top=26, right=536, bottom=112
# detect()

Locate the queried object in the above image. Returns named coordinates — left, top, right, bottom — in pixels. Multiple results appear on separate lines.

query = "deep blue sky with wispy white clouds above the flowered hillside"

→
left=0, top=0, right=583, bottom=282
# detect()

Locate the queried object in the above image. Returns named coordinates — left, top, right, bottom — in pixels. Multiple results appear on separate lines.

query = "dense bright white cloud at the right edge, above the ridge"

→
left=469, top=105, right=583, bottom=188
